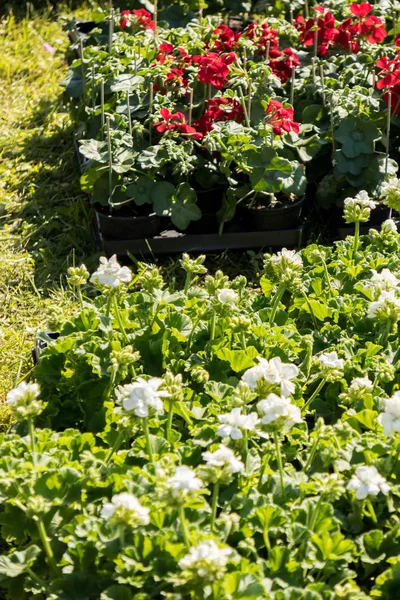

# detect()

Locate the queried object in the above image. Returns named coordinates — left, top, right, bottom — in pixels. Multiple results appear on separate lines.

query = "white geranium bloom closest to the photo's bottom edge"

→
left=178, top=540, right=232, bottom=579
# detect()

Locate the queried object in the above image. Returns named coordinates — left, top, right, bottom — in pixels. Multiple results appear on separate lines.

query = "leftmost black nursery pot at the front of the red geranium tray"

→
left=95, top=209, right=161, bottom=240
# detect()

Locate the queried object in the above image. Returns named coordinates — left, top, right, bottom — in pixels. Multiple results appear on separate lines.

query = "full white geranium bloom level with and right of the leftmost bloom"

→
left=116, top=377, right=169, bottom=418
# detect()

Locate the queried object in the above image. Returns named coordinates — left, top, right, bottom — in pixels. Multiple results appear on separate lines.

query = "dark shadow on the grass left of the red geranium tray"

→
left=7, top=92, right=97, bottom=292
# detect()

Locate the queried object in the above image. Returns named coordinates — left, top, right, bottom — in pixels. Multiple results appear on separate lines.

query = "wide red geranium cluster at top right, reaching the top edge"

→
left=295, top=2, right=387, bottom=56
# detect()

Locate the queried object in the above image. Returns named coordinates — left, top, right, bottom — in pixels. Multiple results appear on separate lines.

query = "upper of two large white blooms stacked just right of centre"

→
left=242, top=356, right=299, bottom=396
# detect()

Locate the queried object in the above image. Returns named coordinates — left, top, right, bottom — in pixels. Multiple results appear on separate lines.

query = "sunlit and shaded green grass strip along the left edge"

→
left=0, top=5, right=95, bottom=412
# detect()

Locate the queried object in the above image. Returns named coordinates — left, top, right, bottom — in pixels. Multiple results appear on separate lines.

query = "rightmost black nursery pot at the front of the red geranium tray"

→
left=241, top=196, right=305, bottom=231
